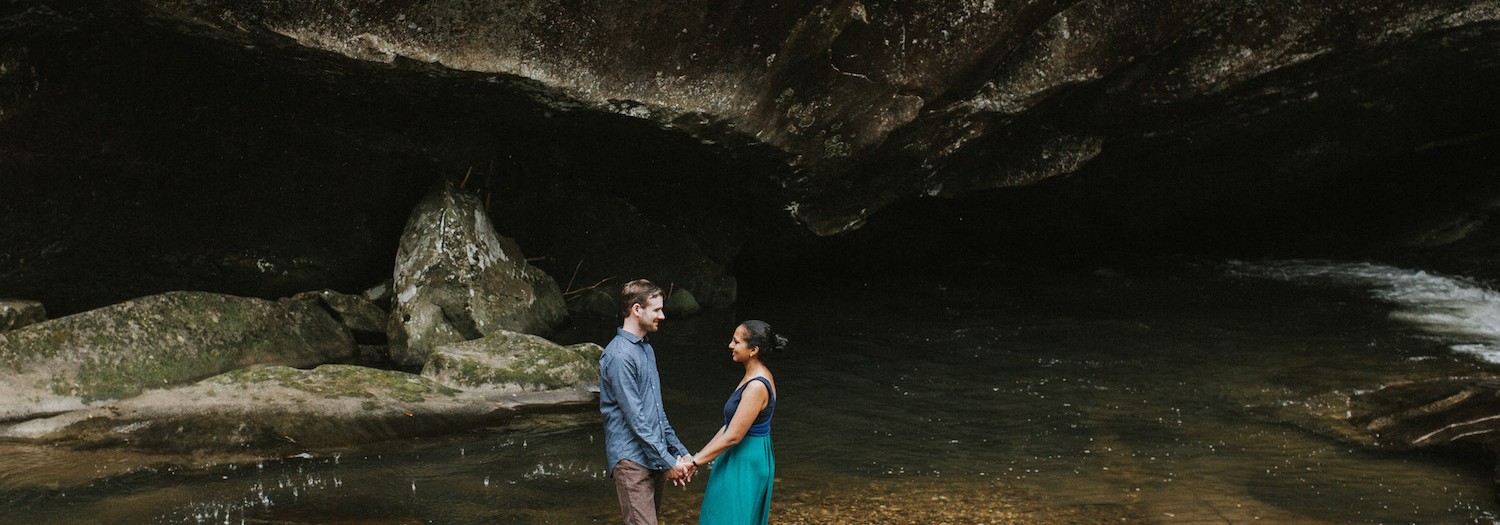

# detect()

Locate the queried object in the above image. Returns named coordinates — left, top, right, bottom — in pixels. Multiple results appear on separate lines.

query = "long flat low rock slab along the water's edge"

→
left=0, top=365, right=594, bottom=452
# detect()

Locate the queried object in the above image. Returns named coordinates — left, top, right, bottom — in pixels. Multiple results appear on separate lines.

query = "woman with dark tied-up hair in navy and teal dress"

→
left=693, top=321, right=786, bottom=525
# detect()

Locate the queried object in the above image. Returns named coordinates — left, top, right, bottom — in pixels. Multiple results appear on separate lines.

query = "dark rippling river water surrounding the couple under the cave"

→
left=0, top=261, right=1500, bottom=524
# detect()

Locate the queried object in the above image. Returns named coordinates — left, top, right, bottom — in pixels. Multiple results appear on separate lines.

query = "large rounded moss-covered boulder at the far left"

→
left=0, top=293, right=354, bottom=420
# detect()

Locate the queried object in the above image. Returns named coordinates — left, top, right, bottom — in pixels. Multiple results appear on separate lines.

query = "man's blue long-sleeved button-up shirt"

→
left=599, top=329, right=687, bottom=476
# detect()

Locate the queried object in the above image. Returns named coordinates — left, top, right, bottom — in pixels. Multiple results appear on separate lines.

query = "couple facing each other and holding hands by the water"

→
left=599, top=279, right=786, bottom=525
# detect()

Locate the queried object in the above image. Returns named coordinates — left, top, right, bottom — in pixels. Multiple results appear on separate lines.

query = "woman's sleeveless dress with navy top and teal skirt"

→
left=698, top=378, right=776, bottom=525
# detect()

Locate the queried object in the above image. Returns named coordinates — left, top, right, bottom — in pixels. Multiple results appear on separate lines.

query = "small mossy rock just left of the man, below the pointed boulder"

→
left=422, top=332, right=605, bottom=401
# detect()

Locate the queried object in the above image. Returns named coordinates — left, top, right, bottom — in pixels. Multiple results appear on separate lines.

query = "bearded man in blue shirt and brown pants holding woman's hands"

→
left=599, top=279, right=693, bottom=525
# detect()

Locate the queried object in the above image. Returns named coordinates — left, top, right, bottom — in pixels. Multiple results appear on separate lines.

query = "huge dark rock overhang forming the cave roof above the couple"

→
left=0, top=0, right=1500, bottom=312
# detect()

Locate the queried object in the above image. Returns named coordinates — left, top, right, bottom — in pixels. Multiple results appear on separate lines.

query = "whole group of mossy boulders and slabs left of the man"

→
left=0, top=182, right=603, bottom=453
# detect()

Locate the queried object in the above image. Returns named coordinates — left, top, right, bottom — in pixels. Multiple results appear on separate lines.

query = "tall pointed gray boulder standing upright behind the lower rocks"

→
left=389, top=182, right=567, bottom=365
